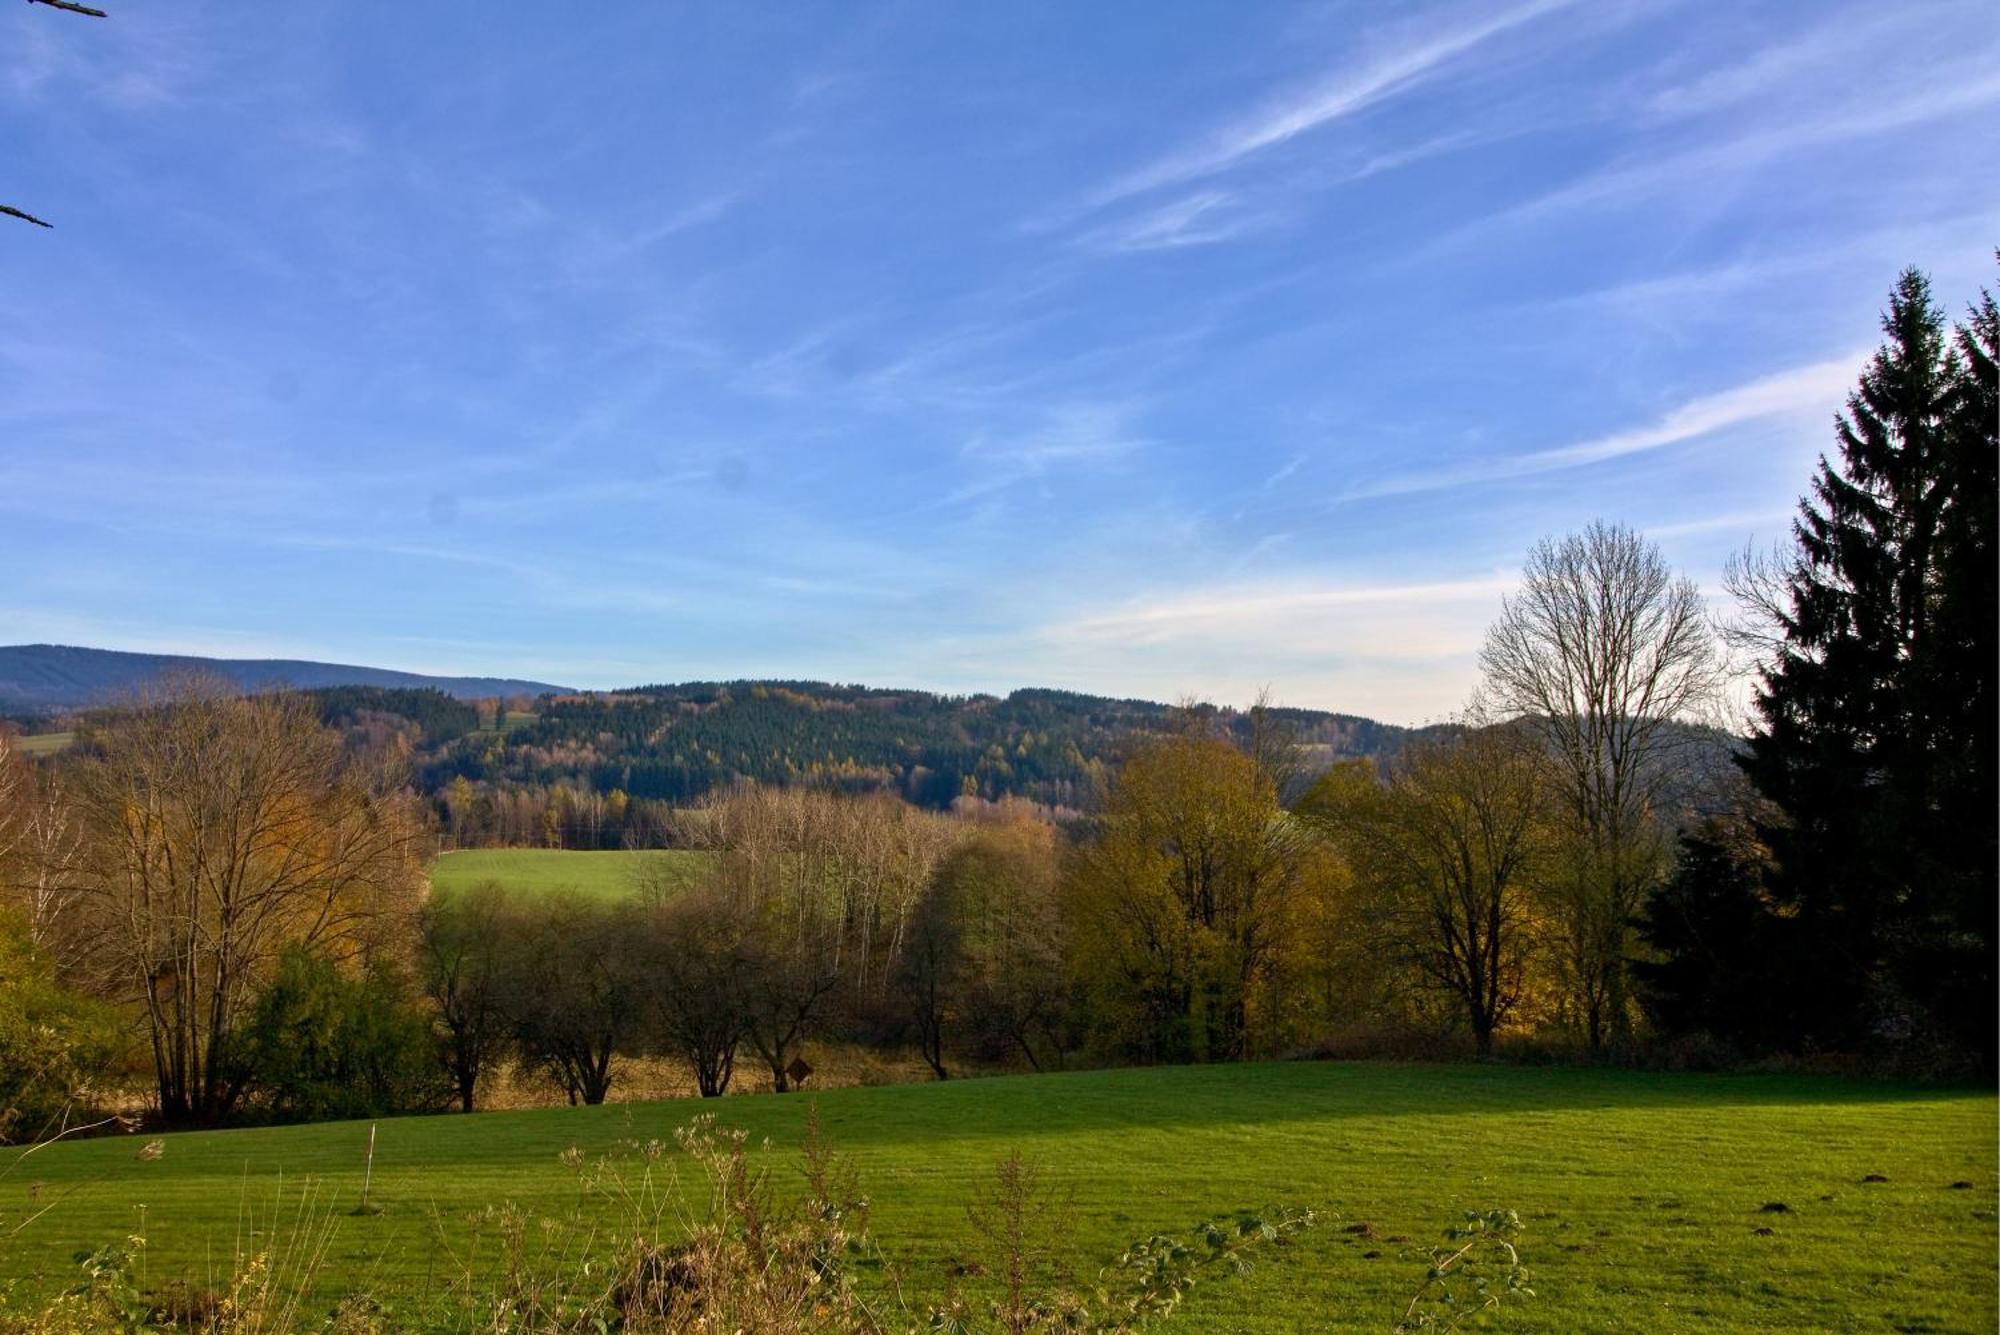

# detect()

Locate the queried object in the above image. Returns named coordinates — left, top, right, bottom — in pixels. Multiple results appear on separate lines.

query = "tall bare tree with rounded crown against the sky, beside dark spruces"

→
left=1480, top=522, right=1724, bottom=1049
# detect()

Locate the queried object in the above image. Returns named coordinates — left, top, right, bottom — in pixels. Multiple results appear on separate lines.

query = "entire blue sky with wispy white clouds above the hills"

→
left=0, top=0, right=2000, bottom=721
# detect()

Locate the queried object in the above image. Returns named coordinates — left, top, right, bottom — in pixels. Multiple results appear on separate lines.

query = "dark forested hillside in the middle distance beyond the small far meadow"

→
left=296, top=681, right=1410, bottom=847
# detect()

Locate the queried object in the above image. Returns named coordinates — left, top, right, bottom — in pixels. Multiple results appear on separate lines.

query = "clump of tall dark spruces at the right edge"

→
left=1744, top=270, right=1996, bottom=1061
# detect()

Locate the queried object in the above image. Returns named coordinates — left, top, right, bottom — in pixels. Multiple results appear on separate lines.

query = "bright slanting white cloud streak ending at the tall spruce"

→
left=1342, top=352, right=1866, bottom=500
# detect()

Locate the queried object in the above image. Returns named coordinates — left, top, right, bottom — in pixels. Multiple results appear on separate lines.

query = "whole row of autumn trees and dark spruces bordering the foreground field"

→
left=0, top=272, right=2000, bottom=1133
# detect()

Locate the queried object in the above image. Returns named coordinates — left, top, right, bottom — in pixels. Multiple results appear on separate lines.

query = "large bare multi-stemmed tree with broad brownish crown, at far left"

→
left=74, top=679, right=418, bottom=1121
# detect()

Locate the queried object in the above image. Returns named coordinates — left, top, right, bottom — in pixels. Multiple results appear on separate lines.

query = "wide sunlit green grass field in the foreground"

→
left=0, top=1063, right=1996, bottom=1331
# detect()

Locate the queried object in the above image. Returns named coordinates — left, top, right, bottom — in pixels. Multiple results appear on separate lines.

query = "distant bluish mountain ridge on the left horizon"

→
left=0, top=644, right=570, bottom=713
